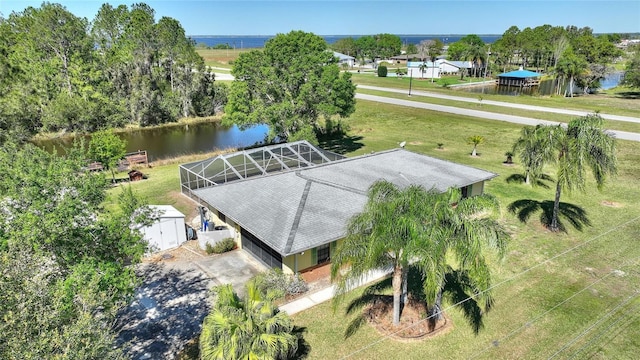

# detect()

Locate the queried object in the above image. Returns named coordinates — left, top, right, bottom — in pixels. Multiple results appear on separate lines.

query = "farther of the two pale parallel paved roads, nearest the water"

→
left=358, top=85, right=640, bottom=123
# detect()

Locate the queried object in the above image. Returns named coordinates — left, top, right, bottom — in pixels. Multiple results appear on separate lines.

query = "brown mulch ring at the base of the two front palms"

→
left=364, top=295, right=453, bottom=341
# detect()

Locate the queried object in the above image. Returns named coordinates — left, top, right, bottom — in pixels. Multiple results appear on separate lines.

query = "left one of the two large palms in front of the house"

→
left=331, top=181, right=428, bottom=326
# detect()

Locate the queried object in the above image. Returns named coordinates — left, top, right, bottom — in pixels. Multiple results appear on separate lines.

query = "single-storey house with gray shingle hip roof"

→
left=181, top=142, right=497, bottom=272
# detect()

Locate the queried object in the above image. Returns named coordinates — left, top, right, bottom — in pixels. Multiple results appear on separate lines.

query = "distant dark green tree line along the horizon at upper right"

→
left=332, top=25, right=624, bottom=93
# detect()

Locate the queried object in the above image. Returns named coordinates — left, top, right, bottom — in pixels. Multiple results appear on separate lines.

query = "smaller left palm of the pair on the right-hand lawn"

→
left=513, top=125, right=554, bottom=185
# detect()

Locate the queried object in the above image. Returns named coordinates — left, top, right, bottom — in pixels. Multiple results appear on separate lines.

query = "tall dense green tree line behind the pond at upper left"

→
left=0, top=3, right=225, bottom=141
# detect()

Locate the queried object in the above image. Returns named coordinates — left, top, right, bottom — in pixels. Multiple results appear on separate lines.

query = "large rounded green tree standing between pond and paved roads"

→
left=223, top=31, right=355, bottom=141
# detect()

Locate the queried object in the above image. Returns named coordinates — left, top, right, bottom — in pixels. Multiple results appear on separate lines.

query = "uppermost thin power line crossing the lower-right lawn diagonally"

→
left=341, top=216, right=640, bottom=359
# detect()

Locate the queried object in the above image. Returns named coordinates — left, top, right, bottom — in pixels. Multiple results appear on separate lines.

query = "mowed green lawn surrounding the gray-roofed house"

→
left=119, top=96, right=640, bottom=359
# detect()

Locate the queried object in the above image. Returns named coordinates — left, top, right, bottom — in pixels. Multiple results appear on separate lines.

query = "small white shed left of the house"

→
left=140, top=205, right=187, bottom=251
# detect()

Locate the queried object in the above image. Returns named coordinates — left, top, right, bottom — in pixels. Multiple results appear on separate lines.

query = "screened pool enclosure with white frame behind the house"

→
left=180, top=140, right=345, bottom=196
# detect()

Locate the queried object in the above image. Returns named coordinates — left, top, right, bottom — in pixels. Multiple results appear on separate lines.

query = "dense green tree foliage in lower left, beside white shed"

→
left=0, top=142, right=148, bottom=359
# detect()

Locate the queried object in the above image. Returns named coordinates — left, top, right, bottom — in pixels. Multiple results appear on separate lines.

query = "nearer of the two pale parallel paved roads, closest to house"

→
left=356, top=93, right=640, bottom=142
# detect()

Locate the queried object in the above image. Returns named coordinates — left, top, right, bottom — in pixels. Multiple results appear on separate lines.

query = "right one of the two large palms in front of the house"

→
left=414, top=188, right=508, bottom=319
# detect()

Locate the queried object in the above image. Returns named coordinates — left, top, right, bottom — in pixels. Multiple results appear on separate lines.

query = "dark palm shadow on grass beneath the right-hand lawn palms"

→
left=508, top=199, right=591, bottom=232
